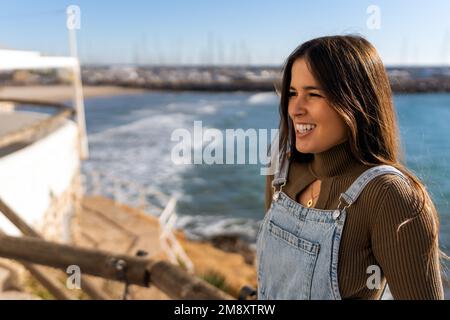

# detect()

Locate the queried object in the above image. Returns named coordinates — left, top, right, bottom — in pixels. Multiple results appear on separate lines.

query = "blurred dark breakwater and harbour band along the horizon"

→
left=0, top=66, right=450, bottom=92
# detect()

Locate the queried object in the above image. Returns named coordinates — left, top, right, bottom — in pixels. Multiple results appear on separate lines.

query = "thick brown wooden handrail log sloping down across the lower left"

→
left=0, top=235, right=233, bottom=300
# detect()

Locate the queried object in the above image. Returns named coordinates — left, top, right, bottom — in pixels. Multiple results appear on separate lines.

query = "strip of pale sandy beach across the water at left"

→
left=0, top=85, right=146, bottom=102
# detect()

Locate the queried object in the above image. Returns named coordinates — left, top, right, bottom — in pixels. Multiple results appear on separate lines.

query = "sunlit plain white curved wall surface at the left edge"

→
left=0, top=120, right=80, bottom=236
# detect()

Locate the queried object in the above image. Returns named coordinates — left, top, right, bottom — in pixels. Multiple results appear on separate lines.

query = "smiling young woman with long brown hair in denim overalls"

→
left=257, top=36, right=443, bottom=299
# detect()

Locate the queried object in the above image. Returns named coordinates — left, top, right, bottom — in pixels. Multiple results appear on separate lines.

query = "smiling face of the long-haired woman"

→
left=288, top=58, right=348, bottom=153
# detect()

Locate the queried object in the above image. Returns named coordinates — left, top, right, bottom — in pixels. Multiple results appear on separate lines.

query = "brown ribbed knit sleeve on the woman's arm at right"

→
left=371, top=175, right=444, bottom=299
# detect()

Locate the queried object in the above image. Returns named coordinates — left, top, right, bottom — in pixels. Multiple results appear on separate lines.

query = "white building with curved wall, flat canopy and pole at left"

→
left=0, top=50, right=88, bottom=240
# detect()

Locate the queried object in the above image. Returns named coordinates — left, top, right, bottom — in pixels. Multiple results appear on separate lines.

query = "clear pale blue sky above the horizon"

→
left=0, top=0, right=450, bottom=65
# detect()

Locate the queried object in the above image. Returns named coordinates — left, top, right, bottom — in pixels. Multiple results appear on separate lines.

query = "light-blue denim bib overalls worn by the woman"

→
left=256, top=160, right=406, bottom=300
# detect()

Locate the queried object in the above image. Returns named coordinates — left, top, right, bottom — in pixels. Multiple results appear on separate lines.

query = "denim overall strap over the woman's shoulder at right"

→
left=338, top=165, right=409, bottom=209
